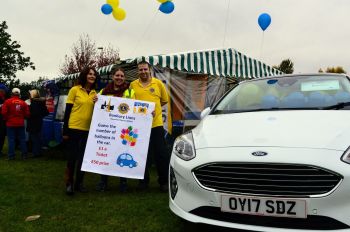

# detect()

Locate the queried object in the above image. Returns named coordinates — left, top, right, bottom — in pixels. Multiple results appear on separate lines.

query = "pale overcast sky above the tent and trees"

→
left=0, top=0, right=350, bottom=82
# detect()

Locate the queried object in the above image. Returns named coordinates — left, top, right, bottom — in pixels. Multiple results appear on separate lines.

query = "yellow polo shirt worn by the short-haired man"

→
left=130, top=77, right=168, bottom=128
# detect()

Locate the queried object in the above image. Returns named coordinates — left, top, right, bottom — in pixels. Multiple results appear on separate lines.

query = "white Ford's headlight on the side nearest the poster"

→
left=173, top=131, right=196, bottom=161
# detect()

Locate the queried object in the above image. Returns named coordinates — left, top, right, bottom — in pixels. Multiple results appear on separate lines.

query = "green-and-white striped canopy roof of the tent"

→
left=56, top=48, right=283, bottom=82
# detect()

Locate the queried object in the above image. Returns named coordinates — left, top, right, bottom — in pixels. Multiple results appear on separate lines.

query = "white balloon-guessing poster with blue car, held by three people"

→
left=82, top=96, right=154, bottom=179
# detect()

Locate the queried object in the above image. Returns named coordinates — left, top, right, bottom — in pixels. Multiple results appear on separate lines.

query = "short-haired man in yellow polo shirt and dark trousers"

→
left=130, top=61, right=169, bottom=192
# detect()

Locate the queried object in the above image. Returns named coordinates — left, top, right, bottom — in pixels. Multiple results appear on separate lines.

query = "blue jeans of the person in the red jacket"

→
left=7, top=126, right=27, bottom=159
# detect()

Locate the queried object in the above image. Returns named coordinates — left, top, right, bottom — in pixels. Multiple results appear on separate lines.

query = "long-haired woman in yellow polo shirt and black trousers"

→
left=63, top=67, right=98, bottom=195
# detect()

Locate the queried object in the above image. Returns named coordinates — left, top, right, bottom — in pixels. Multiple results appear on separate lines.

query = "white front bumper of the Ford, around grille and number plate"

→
left=169, top=147, right=350, bottom=231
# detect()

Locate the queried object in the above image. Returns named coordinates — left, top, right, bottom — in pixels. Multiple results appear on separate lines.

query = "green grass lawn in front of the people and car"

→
left=0, top=145, right=238, bottom=232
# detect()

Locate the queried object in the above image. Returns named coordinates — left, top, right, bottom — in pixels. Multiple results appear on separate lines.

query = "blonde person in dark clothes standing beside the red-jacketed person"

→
left=27, top=89, right=49, bottom=157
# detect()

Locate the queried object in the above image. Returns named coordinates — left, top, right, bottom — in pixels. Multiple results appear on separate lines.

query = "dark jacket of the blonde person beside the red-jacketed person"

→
left=27, top=98, right=49, bottom=133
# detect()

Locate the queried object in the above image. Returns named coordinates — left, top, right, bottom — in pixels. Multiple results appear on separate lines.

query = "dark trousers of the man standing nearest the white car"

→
left=140, top=126, right=170, bottom=185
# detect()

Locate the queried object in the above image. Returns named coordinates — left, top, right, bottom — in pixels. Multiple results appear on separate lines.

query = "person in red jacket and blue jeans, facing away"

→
left=1, top=88, right=30, bottom=160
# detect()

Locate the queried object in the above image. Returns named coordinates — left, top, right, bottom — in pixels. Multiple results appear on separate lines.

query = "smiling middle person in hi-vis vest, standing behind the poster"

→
left=97, top=66, right=135, bottom=192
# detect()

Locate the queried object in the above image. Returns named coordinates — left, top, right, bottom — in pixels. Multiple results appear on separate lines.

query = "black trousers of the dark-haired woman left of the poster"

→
left=66, top=129, right=89, bottom=188
